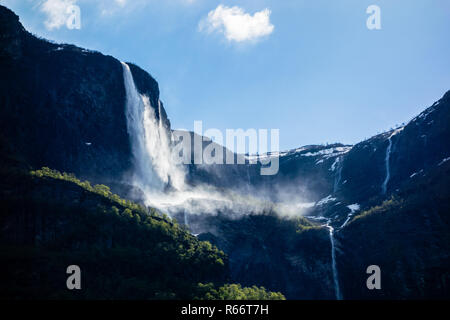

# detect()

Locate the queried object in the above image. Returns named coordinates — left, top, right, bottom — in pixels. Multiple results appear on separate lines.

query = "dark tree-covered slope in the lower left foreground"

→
left=0, top=168, right=283, bottom=299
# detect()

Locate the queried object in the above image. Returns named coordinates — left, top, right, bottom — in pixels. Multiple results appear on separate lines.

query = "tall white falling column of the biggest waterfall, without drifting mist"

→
left=122, top=62, right=185, bottom=198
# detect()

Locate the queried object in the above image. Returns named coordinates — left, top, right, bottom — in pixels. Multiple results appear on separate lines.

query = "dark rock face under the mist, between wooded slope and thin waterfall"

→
left=199, top=214, right=335, bottom=299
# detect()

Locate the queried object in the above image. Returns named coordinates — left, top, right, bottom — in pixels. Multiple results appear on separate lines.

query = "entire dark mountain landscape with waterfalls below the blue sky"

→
left=0, top=6, right=450, bottom=299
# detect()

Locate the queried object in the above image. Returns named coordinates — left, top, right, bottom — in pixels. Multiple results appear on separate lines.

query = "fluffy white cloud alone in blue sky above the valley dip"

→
left=199, top=5, right=275, bottom=42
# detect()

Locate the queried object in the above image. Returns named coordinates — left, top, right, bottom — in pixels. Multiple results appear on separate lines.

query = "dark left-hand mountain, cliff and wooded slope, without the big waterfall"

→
left=0, top=6, right=284, bottom=300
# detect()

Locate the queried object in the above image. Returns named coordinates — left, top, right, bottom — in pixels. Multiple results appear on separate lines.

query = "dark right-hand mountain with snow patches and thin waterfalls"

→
left=195, top=92, right=450, bottom=299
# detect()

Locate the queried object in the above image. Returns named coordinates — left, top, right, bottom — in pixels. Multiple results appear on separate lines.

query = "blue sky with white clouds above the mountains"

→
left=0, top=0, right=450, bottom=150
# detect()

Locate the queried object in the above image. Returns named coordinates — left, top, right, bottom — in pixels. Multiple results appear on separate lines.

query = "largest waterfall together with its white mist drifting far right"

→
left=122, top=62, right=314, bottom=219
